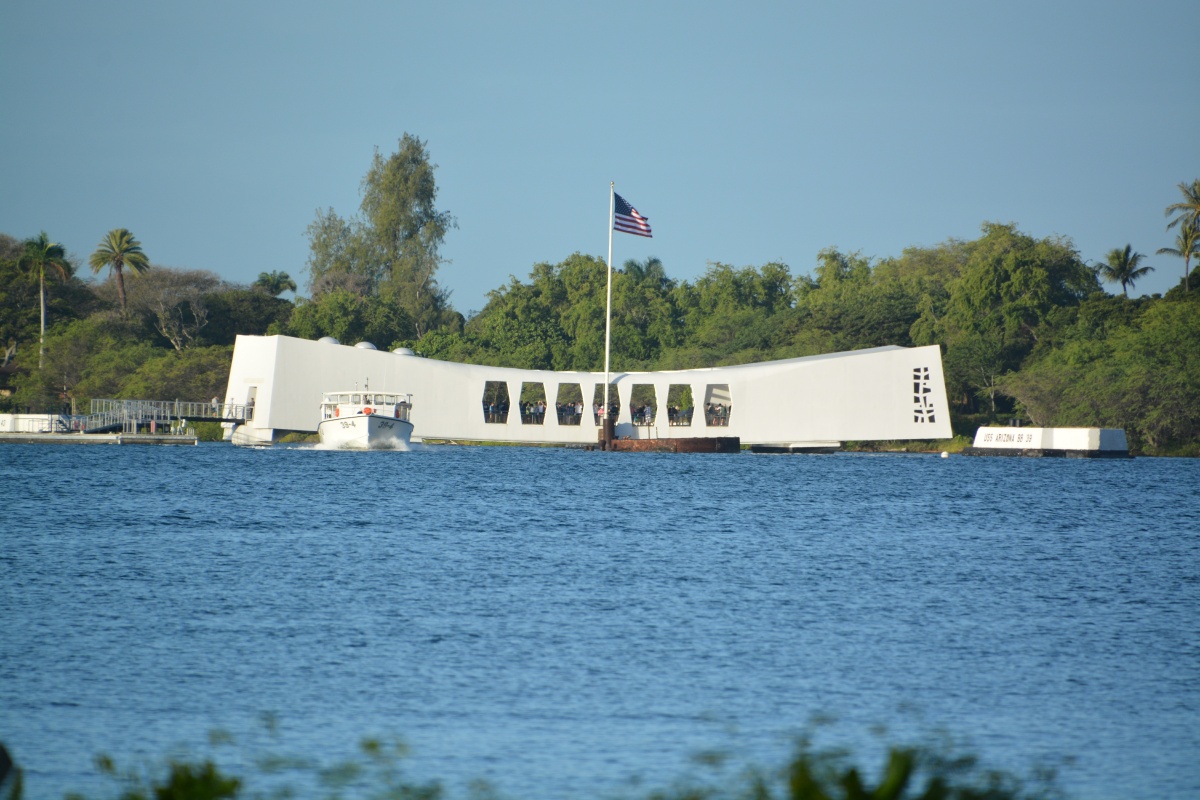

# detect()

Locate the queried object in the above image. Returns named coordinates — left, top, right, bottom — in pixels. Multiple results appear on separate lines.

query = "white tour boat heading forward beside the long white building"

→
left=317, top=390, right=413, bottom=450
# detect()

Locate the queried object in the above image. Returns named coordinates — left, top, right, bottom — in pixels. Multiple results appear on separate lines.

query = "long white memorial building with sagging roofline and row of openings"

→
left=226, top=336, right=952, bottom=446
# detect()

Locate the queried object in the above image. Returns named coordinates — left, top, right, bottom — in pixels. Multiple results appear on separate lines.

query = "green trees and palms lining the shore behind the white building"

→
left=0, top=142, right=1200, bottom=457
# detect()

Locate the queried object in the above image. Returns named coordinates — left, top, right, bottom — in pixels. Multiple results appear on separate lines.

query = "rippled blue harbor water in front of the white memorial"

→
left=0, top=445, right=1200, bottom=800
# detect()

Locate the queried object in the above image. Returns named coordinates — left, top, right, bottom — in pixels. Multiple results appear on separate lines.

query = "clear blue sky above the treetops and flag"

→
left=0, top=0, right=1200, bottom=313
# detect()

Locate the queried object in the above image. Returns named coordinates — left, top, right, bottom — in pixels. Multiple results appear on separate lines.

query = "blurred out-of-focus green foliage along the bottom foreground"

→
left=0, top=732, right=1070, bottom=800
